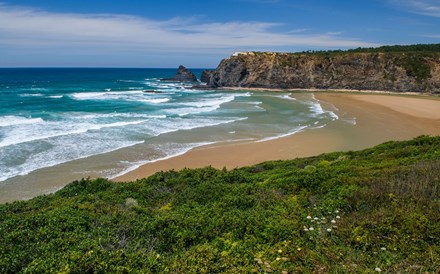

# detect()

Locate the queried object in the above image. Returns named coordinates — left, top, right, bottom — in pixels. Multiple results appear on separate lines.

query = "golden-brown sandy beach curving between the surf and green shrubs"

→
left=114, top=92, right=440, bottom=182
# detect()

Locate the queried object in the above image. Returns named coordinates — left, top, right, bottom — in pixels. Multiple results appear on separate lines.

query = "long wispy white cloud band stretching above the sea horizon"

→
left=0, top=3, right=373, bottom=65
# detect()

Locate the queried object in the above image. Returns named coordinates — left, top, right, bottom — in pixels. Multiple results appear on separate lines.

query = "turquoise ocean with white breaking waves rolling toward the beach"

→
left=0, top=68, right=338, bottom=200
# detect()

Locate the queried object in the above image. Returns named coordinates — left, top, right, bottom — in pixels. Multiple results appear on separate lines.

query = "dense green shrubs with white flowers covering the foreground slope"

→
left=0, top=136, right=440, bottom=273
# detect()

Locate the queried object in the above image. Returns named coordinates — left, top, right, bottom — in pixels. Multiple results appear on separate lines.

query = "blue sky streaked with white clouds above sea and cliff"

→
left=0, top=0, right=440, bottom=68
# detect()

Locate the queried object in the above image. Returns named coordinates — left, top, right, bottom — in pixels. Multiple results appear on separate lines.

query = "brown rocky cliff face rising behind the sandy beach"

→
left=206, top=52, right=440, bottom=93
